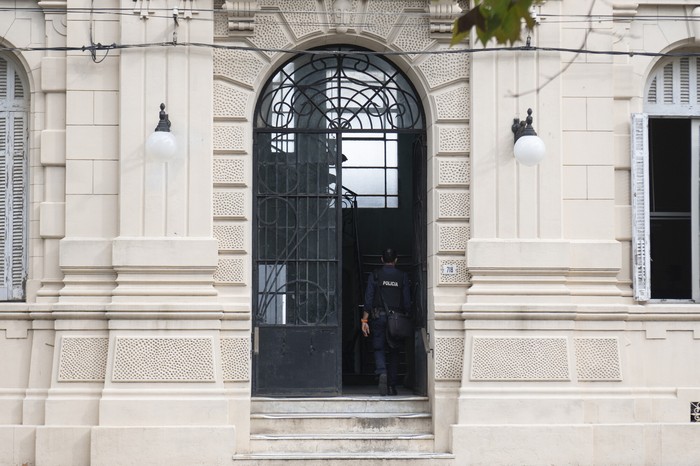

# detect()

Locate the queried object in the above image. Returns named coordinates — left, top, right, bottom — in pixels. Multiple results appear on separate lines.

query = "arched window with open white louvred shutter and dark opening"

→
left=632, top=56, right=700, bottom=302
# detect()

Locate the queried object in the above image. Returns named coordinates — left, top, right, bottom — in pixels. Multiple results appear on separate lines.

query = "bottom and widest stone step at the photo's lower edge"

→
left=233, top=452, right=455, bottom=466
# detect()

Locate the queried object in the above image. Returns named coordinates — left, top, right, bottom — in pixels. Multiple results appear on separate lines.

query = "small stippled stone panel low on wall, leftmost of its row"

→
left=58, top=337, right=109, bottom=382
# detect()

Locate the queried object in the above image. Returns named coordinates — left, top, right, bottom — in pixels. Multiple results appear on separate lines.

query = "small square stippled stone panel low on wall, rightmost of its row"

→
left=574, top=338, right=622, bottom=381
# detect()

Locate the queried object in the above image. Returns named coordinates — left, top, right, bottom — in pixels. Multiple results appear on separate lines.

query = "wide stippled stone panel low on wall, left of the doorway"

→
left=112, top=337, right=214, bottom=382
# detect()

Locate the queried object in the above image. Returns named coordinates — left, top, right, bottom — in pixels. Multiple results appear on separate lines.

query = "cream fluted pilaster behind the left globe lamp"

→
left=112, top=0, right=218, bottom=308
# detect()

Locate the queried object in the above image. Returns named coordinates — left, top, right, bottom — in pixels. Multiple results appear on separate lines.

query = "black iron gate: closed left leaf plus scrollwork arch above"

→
left=253, top=47, right=424, bottom=395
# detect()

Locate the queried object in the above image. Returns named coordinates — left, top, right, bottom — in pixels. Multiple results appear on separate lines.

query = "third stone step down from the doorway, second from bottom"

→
left=250, top=433, right=434, bottom=454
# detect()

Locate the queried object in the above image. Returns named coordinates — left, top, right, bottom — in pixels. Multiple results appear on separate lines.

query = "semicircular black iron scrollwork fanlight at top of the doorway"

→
left=257, top=49, right=423, bottom=130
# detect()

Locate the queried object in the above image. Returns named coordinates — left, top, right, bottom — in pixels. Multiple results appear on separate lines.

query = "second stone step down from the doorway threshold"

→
left=250, top=412, right=432, bottom=434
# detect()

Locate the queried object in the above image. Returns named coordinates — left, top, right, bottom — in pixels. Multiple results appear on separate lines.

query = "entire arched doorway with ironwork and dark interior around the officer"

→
left=253, top=46, right=426, bottom=395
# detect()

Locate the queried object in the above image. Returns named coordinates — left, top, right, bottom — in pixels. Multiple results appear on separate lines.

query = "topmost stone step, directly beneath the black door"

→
left=251, top=395, right=430, bottom=414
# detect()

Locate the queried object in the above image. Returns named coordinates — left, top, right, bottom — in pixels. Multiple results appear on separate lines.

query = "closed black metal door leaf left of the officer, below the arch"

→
left=253, top=133, right=341, bottom=395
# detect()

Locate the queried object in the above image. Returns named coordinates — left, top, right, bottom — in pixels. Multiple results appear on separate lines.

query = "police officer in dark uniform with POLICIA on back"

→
left=361, top=248, right=411, bottom=396
